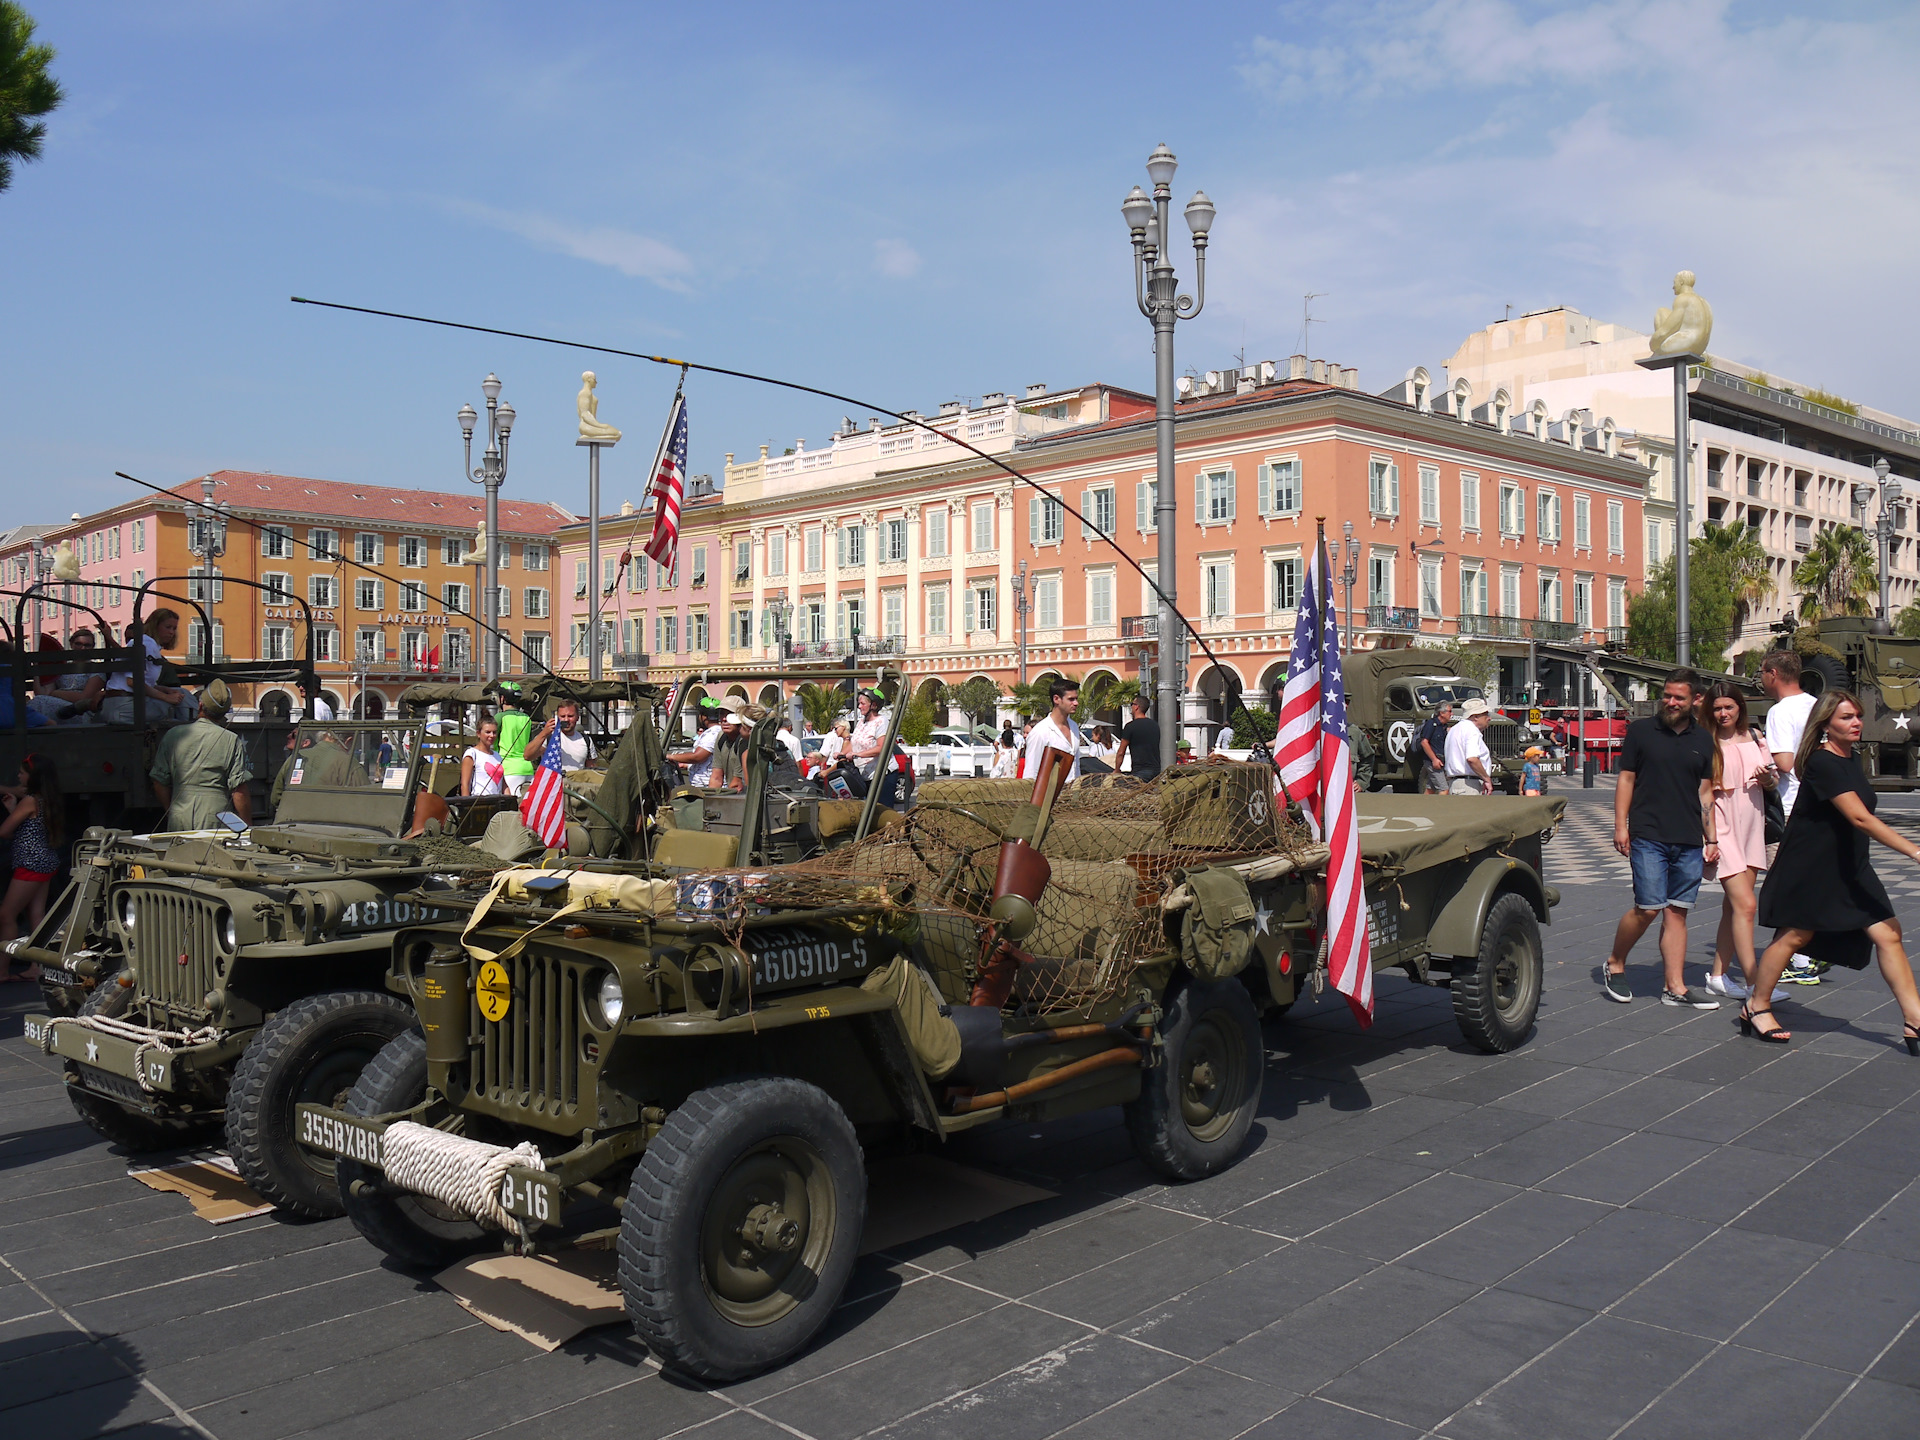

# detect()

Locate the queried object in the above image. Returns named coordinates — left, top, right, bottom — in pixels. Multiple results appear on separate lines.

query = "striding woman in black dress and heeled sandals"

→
left=1740, top=689, right=1920, bottom=1056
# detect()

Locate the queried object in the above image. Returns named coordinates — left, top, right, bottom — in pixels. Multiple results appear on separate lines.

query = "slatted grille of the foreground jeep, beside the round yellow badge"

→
left=470, top=950, right=582, bottom=1123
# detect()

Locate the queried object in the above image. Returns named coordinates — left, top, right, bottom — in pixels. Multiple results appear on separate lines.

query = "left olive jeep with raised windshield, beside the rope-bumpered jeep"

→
left=17, top=722, right=499, bottom=1215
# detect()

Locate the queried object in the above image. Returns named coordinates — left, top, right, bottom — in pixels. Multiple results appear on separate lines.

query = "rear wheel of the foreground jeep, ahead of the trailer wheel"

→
left=1125, top=979, right=1267, bottom=1181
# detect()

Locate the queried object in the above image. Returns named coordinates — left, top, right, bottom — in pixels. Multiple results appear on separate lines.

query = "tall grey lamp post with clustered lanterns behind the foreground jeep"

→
left=1119, top=144, right=1213, bottom=770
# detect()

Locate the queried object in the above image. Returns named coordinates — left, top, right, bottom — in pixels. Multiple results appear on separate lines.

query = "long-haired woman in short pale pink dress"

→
left=1707, top=682, right=1780, bottom=1000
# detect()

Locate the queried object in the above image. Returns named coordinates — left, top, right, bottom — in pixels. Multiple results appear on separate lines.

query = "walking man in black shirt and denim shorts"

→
left=1603, top=670, right=1718, bottom=1010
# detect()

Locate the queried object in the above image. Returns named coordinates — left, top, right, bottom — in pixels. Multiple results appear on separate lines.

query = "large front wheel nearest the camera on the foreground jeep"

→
left=620, top=1077, right=866, bottom=1380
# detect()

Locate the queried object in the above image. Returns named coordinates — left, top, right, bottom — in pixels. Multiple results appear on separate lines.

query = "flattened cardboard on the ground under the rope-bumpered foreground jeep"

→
left=434, top=1156, right=1054, bottom=1350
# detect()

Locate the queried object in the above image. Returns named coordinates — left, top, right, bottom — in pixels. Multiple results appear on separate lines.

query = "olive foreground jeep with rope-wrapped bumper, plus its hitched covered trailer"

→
left=298, top=764, right=1563, bottom=1380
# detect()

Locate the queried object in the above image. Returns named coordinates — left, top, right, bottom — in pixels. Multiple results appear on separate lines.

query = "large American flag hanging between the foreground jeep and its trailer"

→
left=1273, top=543, right=1373, bottom=1027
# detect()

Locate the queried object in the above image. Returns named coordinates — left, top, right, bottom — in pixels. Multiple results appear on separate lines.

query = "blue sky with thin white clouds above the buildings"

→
left=0, top=0, right=1920, bottom=524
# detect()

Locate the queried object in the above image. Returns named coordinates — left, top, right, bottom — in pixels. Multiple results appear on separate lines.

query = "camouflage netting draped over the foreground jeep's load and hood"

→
left=682, top=764, right=1313, bottom=1014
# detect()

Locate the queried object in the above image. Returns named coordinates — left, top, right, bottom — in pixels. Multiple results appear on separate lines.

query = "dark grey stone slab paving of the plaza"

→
left=0, top=781, right=1920, bottom=1440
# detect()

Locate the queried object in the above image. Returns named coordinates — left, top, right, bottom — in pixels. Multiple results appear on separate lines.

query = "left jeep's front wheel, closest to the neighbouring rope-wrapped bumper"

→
left=227, top=991, right=413, bottom=1219
